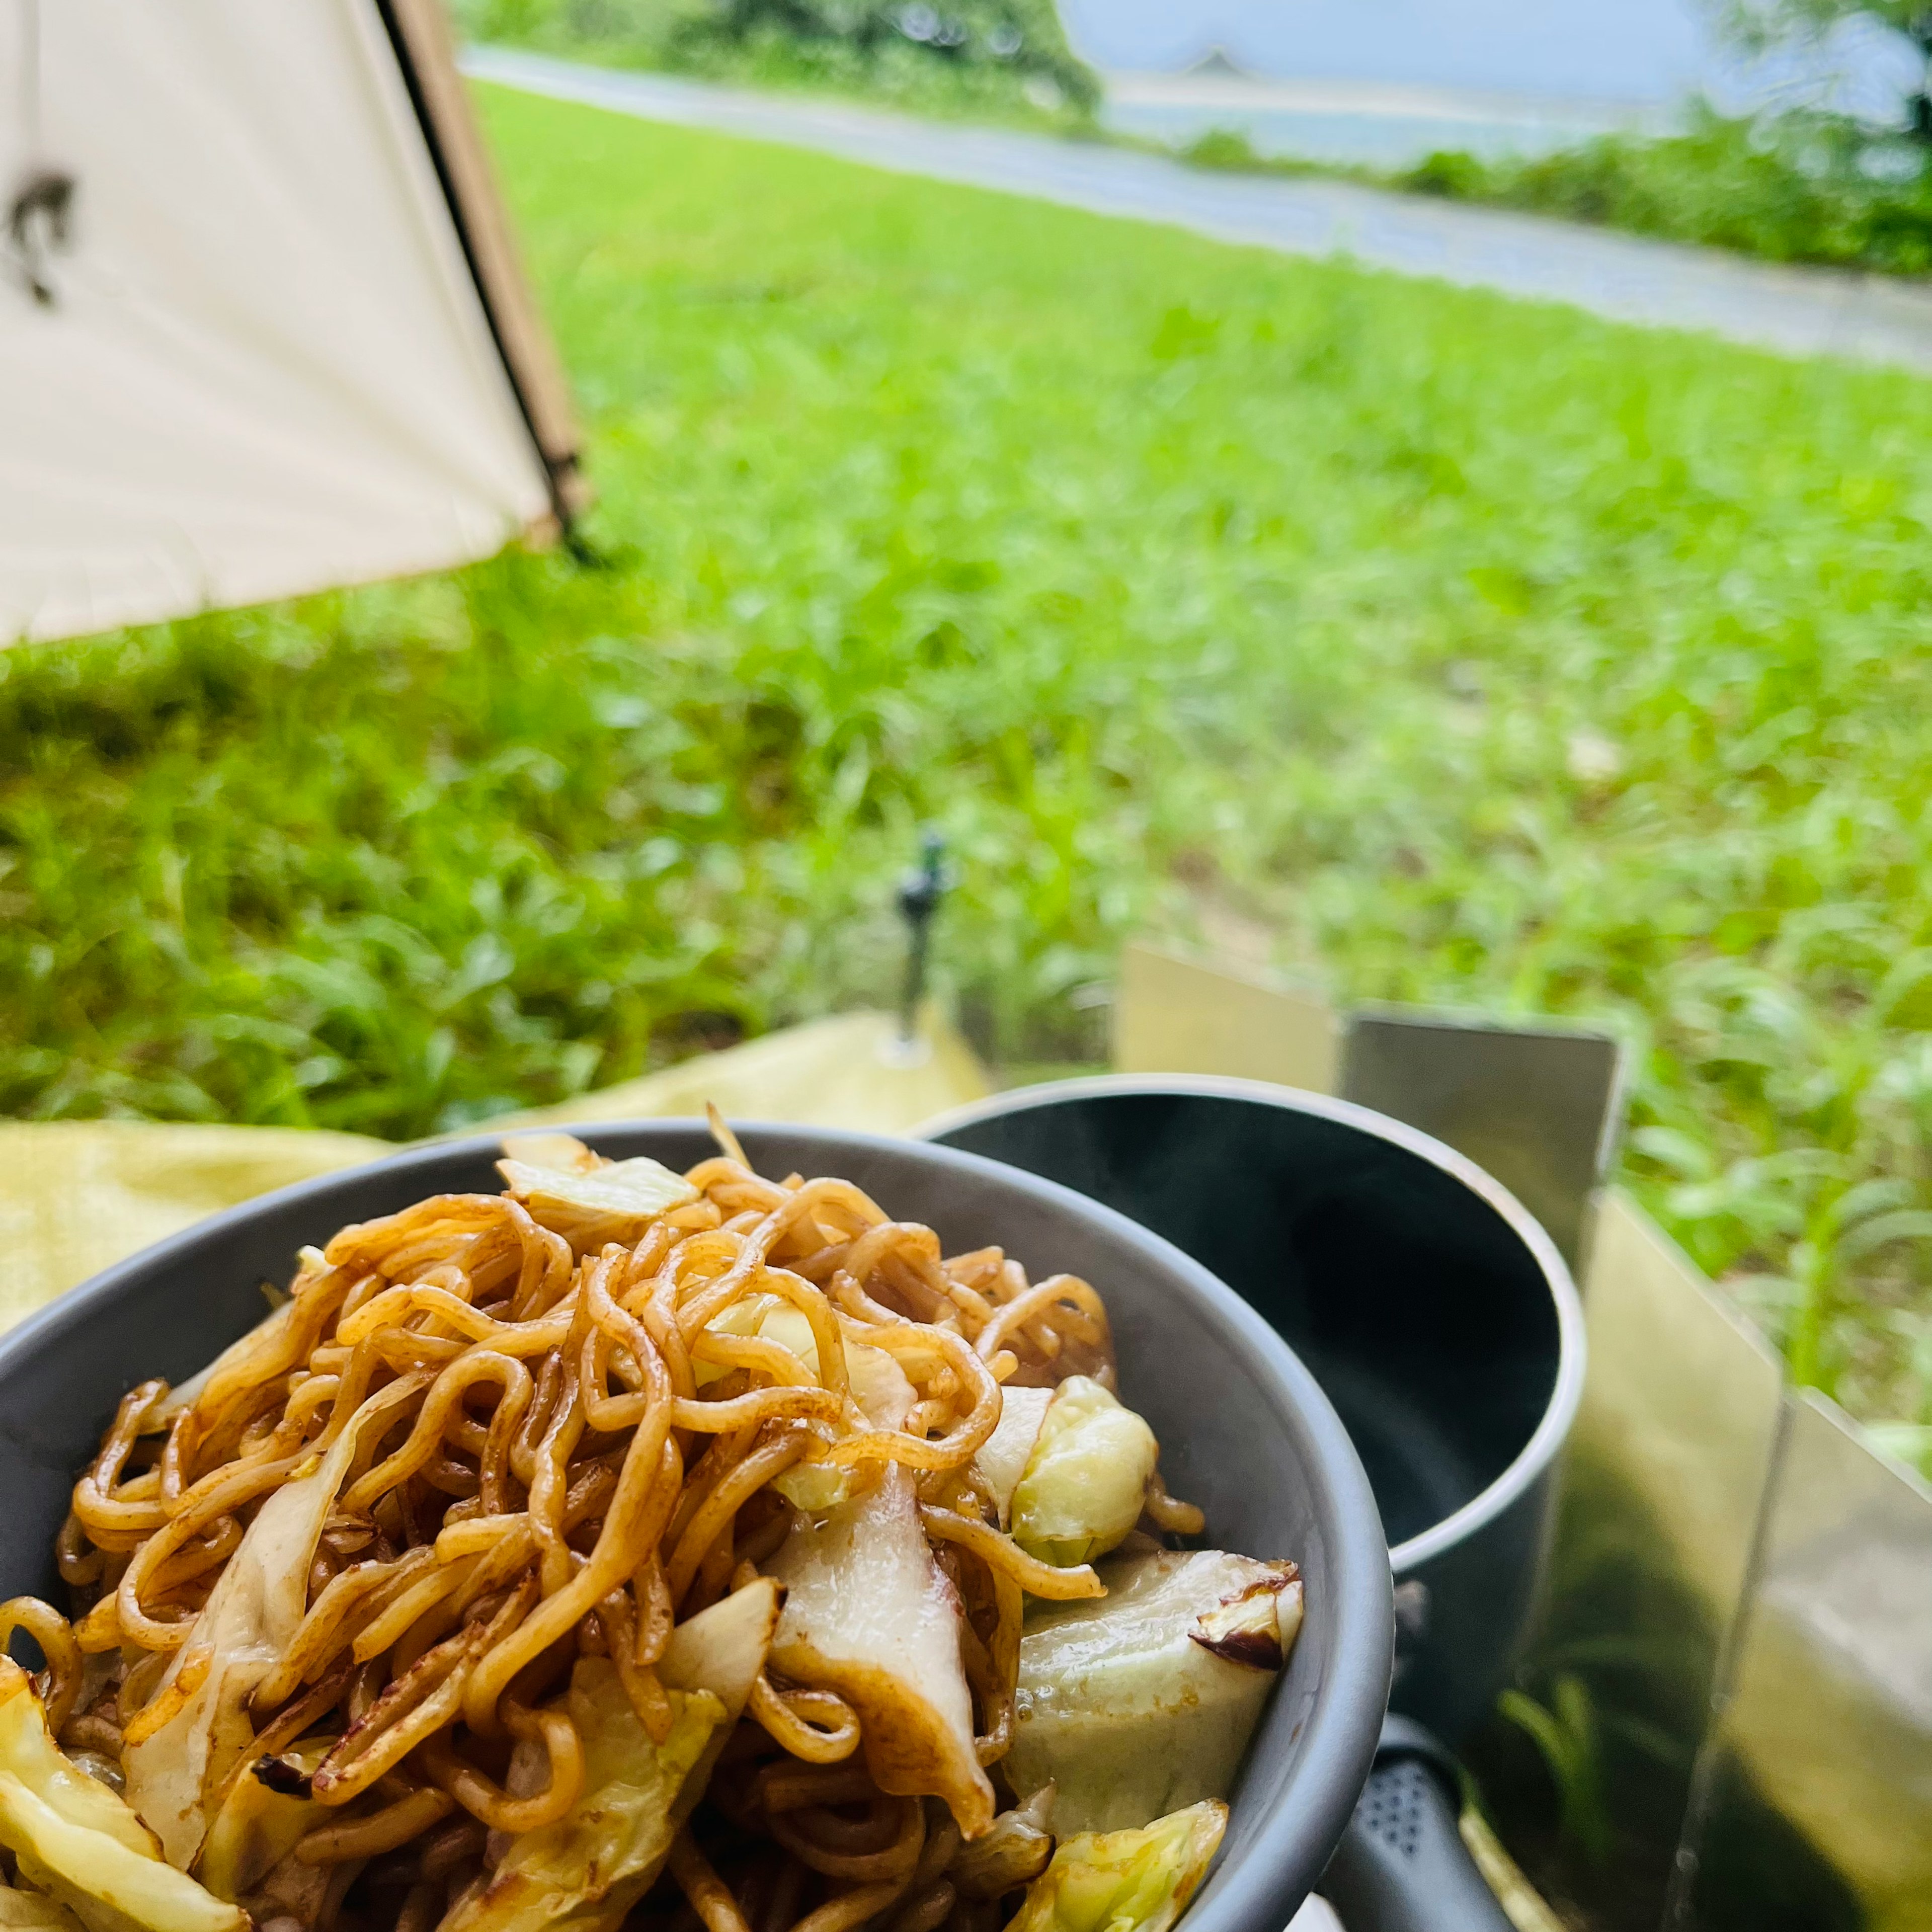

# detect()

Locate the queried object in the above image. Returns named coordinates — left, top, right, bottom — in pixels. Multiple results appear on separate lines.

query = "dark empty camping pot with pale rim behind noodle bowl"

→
left=927, top=1074, right=1584, bottom=1932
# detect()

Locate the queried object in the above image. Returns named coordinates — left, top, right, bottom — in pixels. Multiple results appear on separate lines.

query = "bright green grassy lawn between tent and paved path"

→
left=0, top=93, right=1932, bottom=1453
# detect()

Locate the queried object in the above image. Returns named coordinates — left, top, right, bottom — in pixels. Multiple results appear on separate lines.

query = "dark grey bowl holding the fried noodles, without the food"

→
left=0, top=1120, right=1391, bottom=1932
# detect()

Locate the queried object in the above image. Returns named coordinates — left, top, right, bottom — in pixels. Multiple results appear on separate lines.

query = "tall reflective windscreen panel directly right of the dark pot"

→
left=1472, top=1190, right=1781, bottom=1932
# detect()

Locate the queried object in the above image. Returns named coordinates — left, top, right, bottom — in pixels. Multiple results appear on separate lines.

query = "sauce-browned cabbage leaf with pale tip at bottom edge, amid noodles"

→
left=439, top=1578, right=779, bottom=1932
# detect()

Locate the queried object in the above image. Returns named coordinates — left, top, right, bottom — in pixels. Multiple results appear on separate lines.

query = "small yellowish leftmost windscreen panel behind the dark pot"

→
left=1113, top=945, right=1341, bottom=1093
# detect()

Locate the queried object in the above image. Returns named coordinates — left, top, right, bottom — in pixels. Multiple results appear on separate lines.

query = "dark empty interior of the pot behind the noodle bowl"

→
left=933, top=1086, right=1561, bottom=1548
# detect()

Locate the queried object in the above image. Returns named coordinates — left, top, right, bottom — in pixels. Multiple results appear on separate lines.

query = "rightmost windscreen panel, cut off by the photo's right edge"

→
left=1669, top=1391, right=1932, bottom=1932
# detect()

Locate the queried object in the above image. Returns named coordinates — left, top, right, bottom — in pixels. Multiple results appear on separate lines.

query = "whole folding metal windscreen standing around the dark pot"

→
left=1118, top=981, right=1932, bottom=1932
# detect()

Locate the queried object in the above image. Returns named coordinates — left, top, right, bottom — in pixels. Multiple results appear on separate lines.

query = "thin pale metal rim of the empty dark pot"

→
left=918, top=1074, right=1590, bottom=1576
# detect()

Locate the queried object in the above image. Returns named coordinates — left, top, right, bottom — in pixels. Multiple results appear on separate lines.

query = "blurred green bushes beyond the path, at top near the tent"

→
left=444, top=0, right=1099, bottom=124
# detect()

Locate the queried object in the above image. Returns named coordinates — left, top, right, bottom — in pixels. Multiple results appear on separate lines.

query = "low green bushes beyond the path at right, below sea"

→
left=1383, top=108, right=1932, bottom=274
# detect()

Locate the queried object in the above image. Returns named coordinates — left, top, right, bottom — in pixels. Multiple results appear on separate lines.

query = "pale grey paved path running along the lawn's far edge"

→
left=464, top=48, right=1932, bottom=373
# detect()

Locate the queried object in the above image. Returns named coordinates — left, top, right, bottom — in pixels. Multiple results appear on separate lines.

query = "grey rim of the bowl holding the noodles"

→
left=0, top=1115, right=1395, bottom=1932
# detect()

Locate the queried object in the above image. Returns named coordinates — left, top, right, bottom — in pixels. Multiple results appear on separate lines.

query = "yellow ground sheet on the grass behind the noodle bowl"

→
left=0, top=1012, right=987, bottom=1329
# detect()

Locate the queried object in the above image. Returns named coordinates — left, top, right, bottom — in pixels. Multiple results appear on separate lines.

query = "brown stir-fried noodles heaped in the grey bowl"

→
left=0, top=1136, right=1200, bottom=1932
